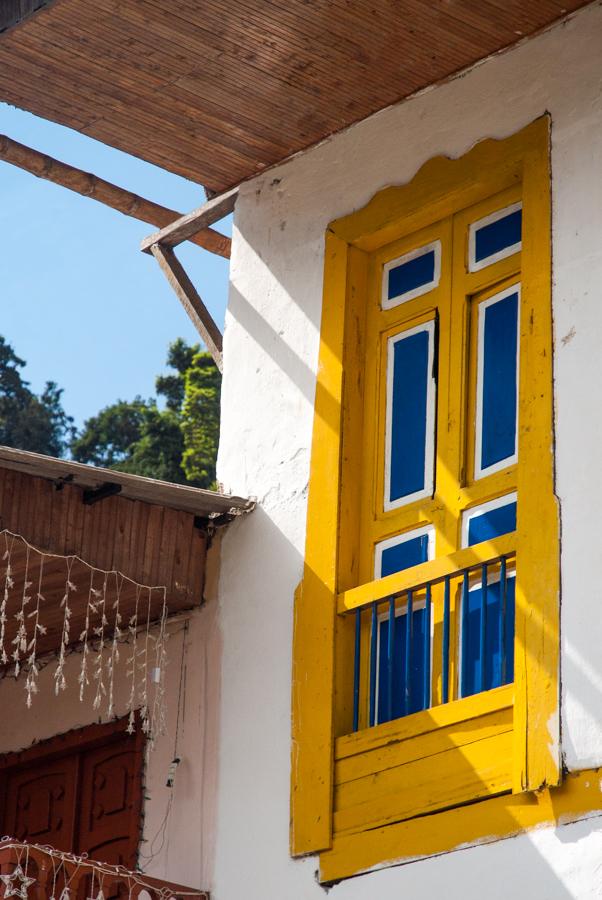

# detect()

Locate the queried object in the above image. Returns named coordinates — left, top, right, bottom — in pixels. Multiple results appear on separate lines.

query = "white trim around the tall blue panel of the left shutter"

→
left=383, top=319, right=437, bottom=512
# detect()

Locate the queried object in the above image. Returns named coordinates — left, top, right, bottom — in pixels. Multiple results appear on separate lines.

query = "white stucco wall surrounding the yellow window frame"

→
left=211, top=4, right=602, bottom=900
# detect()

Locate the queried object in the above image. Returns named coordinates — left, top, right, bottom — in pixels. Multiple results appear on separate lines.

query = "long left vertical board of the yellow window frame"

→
left=290, top=233, right=348, bottom=856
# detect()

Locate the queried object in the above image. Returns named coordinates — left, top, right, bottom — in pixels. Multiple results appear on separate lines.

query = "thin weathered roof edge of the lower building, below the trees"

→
left=0, top=446, right=255, bottom=519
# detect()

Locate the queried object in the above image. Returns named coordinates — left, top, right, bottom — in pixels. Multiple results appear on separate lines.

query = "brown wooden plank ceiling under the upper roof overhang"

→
left=0, top=0, right=588, bottom=191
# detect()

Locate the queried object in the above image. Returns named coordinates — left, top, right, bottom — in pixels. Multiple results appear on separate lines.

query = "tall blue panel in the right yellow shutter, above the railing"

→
left=481, top=292, right=518, bottom=469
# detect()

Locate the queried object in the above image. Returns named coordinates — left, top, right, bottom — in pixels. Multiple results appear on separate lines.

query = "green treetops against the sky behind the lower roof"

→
left=0, top=336, right=221, bottom=488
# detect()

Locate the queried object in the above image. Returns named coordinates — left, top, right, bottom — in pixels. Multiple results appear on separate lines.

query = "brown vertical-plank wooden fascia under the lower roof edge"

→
left=0, top=468, right=207, bottom=612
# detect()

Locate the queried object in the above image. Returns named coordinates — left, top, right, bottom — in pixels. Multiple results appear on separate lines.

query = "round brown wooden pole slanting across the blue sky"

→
left=0, top=135, right=231, bottom=259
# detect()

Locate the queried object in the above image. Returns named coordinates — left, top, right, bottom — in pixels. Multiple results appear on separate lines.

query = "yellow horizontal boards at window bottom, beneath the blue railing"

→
left=334, top=723, right=513, bottom=836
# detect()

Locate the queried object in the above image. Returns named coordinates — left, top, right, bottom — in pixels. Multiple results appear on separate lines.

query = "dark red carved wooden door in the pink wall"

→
left=0, top=722, right=143, bottom=869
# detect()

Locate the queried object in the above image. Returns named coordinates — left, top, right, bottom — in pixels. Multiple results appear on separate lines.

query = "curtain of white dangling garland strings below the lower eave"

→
left=0, top=530, right=168, bottom=746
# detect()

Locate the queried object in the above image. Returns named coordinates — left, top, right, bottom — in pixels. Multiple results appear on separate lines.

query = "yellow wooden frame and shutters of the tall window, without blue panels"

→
left=291, top=118, right=556, bottom=880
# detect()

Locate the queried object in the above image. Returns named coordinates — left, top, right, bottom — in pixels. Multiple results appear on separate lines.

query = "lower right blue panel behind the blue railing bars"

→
left=461, top=578, right=516, bottom=697
